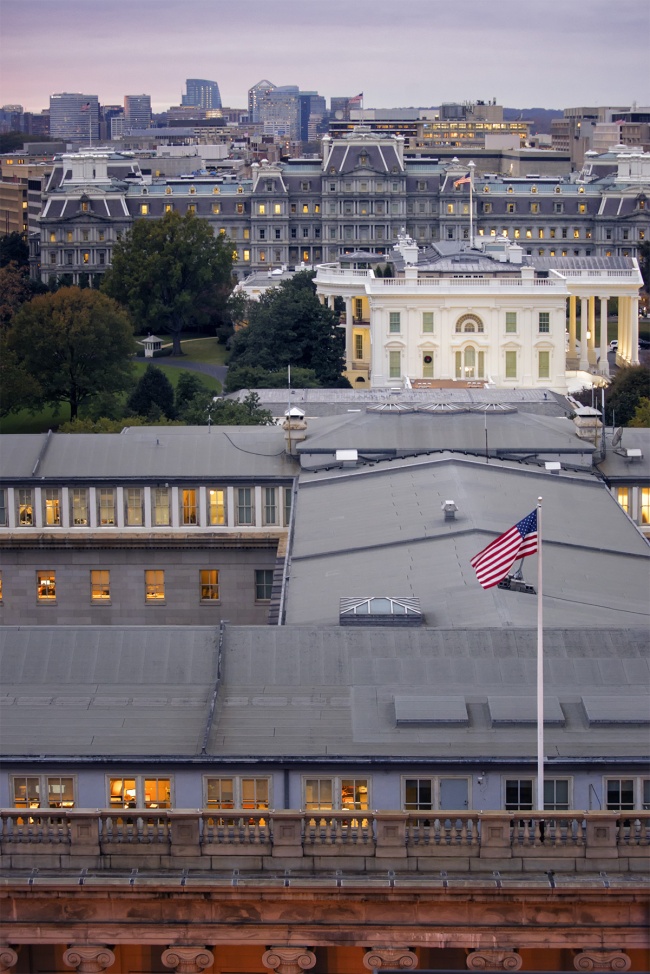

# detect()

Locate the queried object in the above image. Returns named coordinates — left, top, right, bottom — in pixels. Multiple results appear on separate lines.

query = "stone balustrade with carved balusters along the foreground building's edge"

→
left=0, top=808, right=650, bottom=869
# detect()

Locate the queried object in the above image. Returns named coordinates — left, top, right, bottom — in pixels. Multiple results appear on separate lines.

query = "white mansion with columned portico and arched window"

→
left=316, top=232, right=642, bottom=392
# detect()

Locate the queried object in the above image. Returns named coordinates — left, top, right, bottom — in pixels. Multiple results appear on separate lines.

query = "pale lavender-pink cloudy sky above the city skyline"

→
left=0, top=0, right=650, bottom=111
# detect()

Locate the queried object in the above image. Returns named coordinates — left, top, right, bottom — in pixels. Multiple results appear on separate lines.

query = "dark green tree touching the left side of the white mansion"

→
left=230, top=271, right=345, bottom=386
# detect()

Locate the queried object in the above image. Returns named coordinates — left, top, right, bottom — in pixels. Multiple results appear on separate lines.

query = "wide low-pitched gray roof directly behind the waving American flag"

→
left=286, top=454, right=650, bottom=629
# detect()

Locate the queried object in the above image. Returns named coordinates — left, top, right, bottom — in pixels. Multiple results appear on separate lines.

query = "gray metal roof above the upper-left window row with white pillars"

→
left=0, top=426, right=296, bottom=481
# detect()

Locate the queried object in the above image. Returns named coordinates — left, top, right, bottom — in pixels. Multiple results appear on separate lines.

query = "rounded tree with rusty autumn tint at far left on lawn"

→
left=7, top=287, right=135, bottom=419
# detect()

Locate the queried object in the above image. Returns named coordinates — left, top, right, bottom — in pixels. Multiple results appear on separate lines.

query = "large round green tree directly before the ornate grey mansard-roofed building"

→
left=102, top=212, right=233, bottom=355
